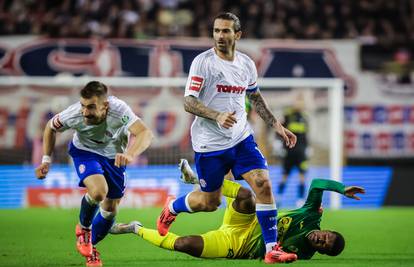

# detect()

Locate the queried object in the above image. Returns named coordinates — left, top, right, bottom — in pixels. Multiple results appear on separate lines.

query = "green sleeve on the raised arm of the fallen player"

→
left=303, top=179, right=345, bottom=210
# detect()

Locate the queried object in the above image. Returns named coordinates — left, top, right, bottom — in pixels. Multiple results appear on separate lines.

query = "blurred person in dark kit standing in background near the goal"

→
left=278, top=93, right=309, bottom=207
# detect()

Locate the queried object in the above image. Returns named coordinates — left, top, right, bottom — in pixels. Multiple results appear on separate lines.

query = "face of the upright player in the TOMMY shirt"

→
left=213, top=19, right=241, bottom=53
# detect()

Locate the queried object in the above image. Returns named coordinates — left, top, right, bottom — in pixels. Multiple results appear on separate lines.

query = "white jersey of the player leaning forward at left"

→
left=51, top=96, right=139, bottom=159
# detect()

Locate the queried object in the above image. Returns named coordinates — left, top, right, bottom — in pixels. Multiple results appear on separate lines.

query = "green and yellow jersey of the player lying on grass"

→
left=251, top=179, right=345, bottom=259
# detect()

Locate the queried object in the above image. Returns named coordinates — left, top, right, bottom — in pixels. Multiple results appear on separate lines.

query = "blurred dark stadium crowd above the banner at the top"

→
left=0, top=0, right=414, bottom=44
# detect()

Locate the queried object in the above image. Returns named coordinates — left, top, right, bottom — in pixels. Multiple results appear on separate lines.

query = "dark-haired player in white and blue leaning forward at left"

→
left=36, top=81, right=152, bottom=266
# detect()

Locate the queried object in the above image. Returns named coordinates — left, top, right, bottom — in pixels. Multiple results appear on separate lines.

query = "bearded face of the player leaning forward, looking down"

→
left=80, top=96, right=108, bottom=125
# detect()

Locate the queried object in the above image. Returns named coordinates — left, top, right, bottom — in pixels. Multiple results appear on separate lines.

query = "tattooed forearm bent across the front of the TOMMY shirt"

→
left=184, top=95, right=237, bottom=129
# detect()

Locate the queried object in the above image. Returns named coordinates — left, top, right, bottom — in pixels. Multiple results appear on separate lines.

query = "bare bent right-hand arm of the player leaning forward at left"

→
left=114, top=120, right=154, bottom=167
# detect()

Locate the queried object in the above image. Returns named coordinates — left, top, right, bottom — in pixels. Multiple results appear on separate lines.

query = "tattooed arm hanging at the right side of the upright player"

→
left=247, top=90, right=296, bottom=148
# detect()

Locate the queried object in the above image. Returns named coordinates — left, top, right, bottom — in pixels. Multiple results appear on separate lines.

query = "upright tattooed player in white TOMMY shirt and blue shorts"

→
left=157, top=13, right=296, bottom=263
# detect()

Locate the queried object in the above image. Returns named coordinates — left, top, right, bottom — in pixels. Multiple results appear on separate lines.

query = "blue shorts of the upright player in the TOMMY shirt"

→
left=194, top=135, right=267, bottom=192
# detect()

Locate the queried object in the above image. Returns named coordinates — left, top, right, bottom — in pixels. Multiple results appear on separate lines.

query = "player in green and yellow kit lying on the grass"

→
left=111, top=163, right=365, bottom=259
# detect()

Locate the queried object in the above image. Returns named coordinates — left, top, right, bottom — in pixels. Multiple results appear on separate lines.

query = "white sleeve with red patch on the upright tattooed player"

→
left=184, top=56, right=206, bottom=98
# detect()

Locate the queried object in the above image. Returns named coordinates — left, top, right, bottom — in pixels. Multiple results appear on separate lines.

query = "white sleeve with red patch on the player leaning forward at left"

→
left=50, top=103, right=82, bottom=132
